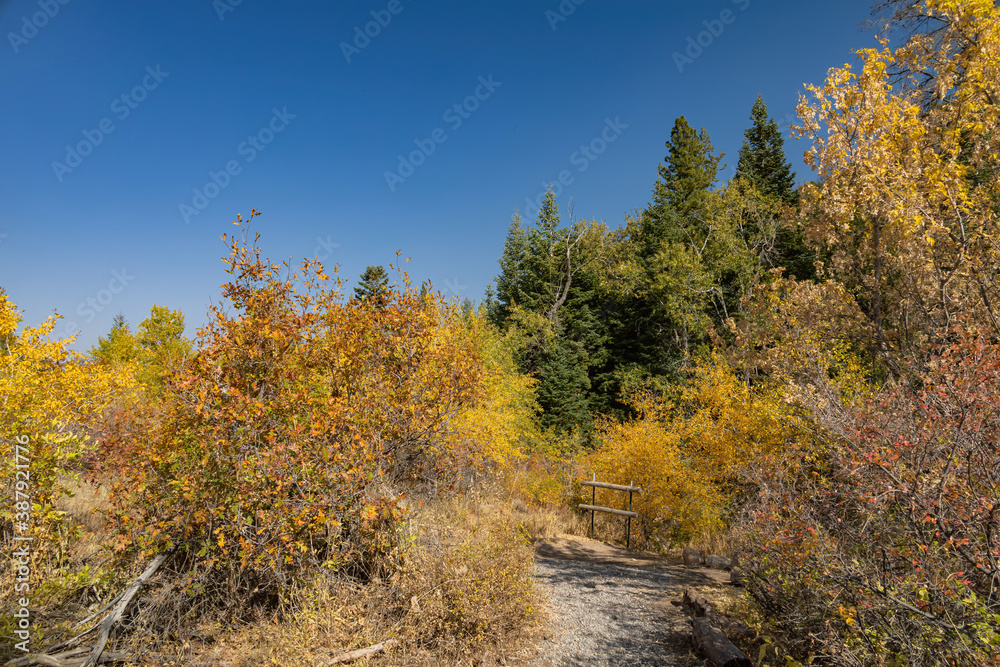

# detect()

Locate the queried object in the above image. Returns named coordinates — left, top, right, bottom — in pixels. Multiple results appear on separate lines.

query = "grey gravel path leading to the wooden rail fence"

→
left=529, top=536, right=728, bottom=667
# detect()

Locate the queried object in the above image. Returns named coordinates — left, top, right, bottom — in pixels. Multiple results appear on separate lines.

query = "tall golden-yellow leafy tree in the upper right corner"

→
left=795, top=0, right=1000, bottom=357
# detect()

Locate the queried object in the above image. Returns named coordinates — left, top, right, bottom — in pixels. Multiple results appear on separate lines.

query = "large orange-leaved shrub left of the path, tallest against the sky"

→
left=96, top=211, right=492, bottom=620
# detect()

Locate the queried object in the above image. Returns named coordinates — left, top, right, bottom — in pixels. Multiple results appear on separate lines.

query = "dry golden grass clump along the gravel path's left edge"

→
left=132, top=494, right=541, bottom=667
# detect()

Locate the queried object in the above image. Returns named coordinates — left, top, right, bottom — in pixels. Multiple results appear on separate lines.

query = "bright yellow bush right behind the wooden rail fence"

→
left=592, top=355, right=795, bottom=541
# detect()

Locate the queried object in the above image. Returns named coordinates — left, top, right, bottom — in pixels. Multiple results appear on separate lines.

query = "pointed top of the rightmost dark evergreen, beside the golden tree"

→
left=735, top=95, right=798, bottom=204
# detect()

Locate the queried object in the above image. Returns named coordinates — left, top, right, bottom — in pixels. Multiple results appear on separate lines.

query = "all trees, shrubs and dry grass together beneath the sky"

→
left=0, top=0, right=1000, bottom=667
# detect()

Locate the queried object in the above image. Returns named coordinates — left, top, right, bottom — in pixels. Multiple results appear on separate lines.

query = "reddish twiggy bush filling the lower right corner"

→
left=745, top=330, right=1000, bottom=666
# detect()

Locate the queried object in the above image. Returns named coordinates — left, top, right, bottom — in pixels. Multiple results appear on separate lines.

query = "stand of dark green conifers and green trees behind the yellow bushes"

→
left=485, top=97, right=817, bottom=442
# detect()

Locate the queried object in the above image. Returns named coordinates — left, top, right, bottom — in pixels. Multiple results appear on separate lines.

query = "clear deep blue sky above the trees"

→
left=0, top=0, right=872, bottom=351
